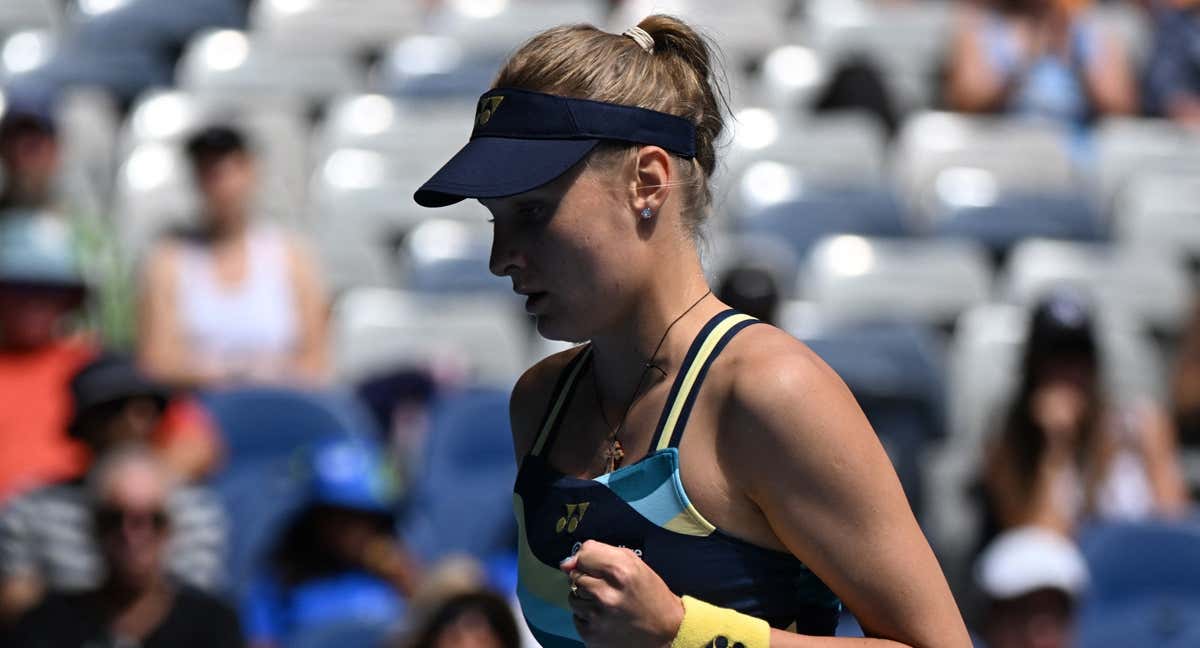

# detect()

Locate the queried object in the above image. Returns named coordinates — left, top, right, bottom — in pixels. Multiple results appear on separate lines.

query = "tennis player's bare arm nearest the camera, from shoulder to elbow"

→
left=721, top=338, right=971, bottom=648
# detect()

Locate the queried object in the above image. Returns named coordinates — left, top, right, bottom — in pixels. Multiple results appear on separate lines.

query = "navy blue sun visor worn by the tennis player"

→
left=414, top=88, right=696, bottom=208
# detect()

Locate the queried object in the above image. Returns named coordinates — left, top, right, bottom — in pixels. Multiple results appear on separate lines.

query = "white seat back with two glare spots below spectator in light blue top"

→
left=892, top=113, right=1079, bottom=222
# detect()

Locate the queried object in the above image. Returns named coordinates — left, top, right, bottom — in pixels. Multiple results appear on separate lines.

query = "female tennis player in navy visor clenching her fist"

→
left=415, top=16, right=970, bottom=648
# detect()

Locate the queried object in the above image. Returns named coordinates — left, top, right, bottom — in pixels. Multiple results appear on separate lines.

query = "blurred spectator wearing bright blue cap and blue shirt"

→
left=242, top=440, right=418, bottom=647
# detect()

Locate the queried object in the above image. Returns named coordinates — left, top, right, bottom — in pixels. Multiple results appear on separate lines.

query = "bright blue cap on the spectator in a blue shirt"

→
left=312, top=439, right=398, bottom=515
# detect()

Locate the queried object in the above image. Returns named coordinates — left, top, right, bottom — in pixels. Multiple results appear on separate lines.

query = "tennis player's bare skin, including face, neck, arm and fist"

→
left=481, top=146, right=970, bottom=648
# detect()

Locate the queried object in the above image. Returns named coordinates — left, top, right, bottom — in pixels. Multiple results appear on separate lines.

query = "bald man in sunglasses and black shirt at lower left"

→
left=13, top=446, right=244, bottom=648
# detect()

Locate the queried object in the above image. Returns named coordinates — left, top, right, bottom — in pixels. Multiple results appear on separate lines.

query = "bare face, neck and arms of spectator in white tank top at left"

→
left=138, top=154, right=329, bottom=386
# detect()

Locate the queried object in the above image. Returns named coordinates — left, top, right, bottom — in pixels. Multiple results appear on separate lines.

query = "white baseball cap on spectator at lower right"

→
left=976, top=527, right=1088, bottom=600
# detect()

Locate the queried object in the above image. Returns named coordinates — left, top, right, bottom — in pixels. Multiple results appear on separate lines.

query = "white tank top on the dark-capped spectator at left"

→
left=175, top=227, right=299, bottom=376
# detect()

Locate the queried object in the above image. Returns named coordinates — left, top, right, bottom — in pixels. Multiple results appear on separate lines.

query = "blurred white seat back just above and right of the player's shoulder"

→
left=798, top=235, right=991, bottom=324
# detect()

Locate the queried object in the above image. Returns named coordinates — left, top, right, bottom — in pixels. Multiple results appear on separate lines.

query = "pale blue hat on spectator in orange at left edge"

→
left=0, top=214, right=85, bottom=290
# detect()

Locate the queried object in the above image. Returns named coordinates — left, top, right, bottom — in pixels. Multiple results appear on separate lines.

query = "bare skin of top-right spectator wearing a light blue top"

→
left=947, top=0, right=1138, bottom=115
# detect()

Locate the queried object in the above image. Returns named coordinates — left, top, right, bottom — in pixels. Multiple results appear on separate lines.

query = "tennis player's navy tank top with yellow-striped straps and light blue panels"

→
left=514, top=310, right=841, bottom=648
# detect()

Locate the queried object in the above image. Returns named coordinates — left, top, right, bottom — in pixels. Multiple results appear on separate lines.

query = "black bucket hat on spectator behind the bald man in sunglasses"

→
left=67, top=353, right=170, bottom=438
